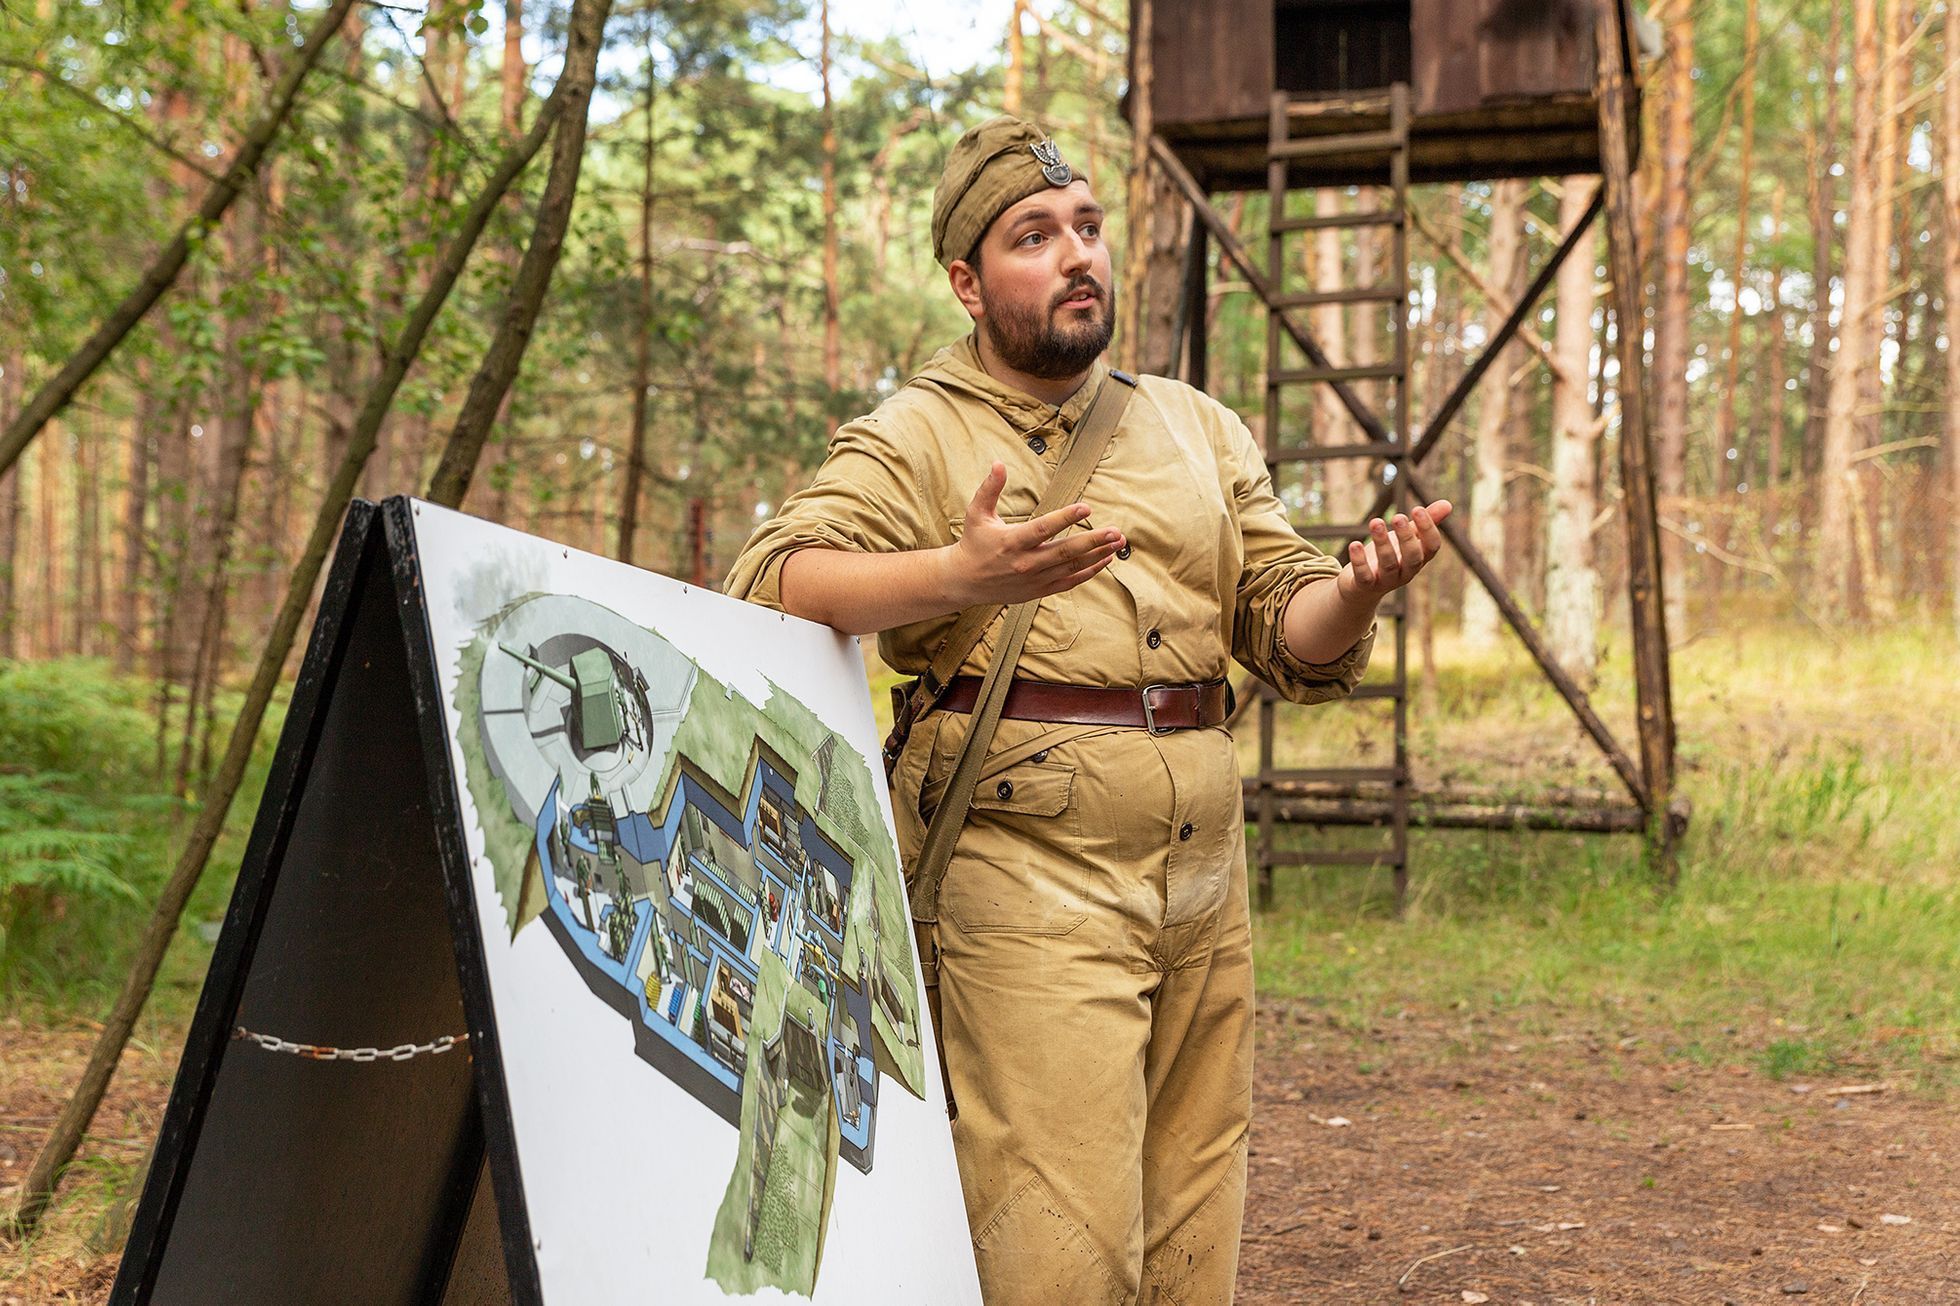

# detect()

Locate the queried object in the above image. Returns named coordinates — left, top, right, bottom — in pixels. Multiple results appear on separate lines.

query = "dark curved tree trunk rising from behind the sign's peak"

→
left=429, top=0, right=612, bottom=508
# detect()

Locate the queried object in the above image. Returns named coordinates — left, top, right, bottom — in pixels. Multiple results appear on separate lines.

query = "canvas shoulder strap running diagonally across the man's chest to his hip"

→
left=906, top=369, right=1137, bottom=922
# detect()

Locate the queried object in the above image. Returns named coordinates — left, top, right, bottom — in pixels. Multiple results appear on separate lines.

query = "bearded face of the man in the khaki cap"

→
left=972, top=180, right=1115, bottom=380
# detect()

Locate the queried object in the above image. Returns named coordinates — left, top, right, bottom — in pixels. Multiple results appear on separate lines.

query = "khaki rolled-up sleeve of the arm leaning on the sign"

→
left=723, top=418, right=927, bottom=612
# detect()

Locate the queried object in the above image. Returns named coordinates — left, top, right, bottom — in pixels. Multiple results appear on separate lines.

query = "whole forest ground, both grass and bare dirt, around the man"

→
left=0, top=622, right=1960, bottom=1306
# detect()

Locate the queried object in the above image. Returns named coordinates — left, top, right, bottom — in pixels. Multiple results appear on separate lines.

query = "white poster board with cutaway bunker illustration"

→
left=414, top=504, right=980, bottom=1304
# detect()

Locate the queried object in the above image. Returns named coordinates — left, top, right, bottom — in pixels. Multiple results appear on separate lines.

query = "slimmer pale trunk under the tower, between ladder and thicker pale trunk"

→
left=1462, top=180, right=1527, bottom=649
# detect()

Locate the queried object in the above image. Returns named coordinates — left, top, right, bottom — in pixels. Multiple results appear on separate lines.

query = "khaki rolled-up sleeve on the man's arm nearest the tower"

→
left=1223, top=414, right=1374, bottom=702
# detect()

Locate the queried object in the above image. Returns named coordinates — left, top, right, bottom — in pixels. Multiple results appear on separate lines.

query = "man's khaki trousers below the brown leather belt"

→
left=909, top=722, right=1252, bottom=1306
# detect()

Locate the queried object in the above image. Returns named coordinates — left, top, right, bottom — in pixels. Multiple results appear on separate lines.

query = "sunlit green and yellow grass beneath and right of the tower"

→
left=1256, top=628, right=1960, bottom=1082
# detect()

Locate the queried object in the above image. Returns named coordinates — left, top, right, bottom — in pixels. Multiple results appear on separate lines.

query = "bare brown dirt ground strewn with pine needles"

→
left=0, top=1004, right=1960, bottom=1306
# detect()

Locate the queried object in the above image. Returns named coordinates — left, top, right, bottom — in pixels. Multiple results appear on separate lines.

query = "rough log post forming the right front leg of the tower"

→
left=1593, top=0, right=1678, bottom=884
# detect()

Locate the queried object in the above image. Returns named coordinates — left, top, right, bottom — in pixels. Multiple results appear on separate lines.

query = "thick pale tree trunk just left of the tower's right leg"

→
left=1544, top=176, right=1599, bottom=682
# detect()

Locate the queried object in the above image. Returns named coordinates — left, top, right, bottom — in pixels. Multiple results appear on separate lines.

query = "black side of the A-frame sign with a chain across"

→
left=110, top=498, right=543, bottom=1306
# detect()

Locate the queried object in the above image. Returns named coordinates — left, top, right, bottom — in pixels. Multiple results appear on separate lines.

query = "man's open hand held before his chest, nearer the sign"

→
left=949, top=463, right=1125, bottom=608
